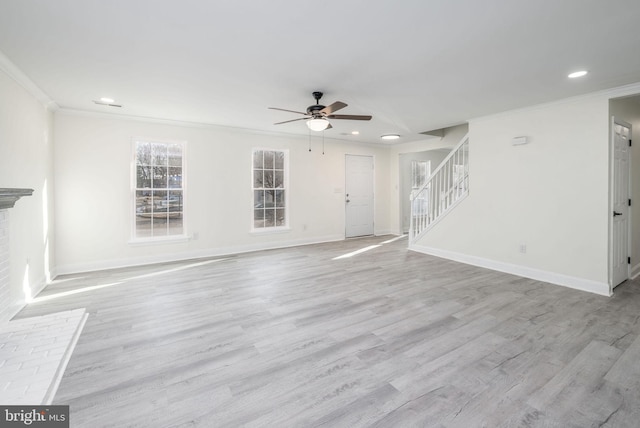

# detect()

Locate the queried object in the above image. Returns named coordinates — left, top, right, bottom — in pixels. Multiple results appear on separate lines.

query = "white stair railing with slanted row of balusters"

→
left=409, top=134, right=469, bottom=245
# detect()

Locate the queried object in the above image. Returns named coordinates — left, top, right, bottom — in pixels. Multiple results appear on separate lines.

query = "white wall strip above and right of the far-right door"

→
left=609, top=96, right=640, bottom=277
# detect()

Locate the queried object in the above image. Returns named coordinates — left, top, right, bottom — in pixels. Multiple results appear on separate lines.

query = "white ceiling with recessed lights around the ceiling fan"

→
left=0, top=0, right=640, bottom=143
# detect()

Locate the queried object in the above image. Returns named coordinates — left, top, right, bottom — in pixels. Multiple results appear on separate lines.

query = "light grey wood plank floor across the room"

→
left=20, top=237, right=640, bottom=428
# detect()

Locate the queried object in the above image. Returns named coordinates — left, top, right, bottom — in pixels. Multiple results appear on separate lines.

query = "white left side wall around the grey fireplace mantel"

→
left=0, top=68, right=55, bottom=322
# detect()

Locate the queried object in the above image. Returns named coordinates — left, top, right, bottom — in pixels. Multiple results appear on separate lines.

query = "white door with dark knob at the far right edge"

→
left=609, top=118, right=631, bottom=287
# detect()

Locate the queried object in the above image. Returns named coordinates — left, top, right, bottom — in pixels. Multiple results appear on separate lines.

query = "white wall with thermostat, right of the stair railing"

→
left=410, top=95, right=609, bottom=294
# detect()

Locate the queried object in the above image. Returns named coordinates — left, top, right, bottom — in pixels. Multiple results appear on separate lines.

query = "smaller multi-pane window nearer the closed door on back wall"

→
left=253, top=149, right=289, bottom=230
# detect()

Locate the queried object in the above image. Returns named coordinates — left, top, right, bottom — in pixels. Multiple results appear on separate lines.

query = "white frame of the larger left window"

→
left=129, top=137, right=189, bottom=245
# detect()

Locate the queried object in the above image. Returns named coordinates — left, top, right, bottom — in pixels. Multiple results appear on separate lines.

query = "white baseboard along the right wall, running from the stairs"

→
left=409, top=245, right=613, bottom=297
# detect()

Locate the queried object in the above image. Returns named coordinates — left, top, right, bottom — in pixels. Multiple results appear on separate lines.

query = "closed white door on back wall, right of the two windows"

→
left=345, top=155, right=373, bottom=238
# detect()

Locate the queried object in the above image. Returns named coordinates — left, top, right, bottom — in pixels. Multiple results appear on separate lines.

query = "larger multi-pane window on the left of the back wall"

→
left=133, top=140, right=185, bottom=239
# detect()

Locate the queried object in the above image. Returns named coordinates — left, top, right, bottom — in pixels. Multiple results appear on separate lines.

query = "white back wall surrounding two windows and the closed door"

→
left=55, top=111, right=390, bottom=273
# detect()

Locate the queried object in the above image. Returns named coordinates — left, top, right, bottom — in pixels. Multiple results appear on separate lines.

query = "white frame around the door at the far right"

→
left=608, top=116, right=633, bottom=292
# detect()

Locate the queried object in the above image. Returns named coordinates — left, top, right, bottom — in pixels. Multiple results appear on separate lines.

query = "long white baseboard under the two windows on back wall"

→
left=56, top=235, right=344, bottom=275
